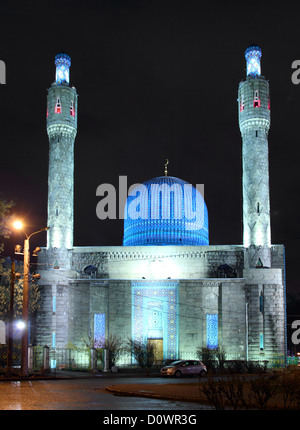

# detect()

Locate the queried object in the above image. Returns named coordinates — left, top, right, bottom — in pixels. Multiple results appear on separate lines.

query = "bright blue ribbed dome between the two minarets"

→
left=123, top=176, right=209, bottom=246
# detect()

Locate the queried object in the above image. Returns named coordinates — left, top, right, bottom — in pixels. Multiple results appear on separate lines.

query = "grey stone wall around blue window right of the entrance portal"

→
left=179, top=279, right=245, bottom=359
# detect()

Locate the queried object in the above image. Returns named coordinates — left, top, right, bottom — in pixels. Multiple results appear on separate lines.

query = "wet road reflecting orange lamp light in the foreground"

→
left=0, top=376, right=207, bottom=411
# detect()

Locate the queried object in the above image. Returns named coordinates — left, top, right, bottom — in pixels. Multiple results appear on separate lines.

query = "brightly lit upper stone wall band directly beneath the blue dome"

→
left=68, top=246, right=244, bottom=280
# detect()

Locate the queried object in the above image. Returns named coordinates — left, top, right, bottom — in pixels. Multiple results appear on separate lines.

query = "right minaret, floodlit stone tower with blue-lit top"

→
left=238, top=46, right=271, bottom=267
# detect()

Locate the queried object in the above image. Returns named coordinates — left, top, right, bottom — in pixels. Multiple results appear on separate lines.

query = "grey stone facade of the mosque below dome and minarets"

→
left=36, top=246, right=285, bottom=360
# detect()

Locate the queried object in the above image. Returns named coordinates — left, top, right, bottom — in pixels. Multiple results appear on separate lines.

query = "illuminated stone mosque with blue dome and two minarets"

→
left=33, top=46, right=286, bottom=361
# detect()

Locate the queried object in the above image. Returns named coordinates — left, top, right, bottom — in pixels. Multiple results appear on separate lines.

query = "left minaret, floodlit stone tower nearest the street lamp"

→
left=47, top=53, right=77, bottom=268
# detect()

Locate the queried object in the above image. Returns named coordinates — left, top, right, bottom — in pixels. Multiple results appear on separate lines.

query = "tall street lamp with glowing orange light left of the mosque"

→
left=14, top=221, right=50, bottom=376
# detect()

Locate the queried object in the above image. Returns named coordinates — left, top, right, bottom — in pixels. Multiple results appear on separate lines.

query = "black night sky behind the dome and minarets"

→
left=0, top=0, right=300, bottom=314
